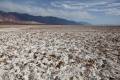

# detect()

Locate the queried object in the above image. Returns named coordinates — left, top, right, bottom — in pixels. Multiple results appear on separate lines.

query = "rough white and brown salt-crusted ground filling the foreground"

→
left=0, top=31, right=120, bottom=80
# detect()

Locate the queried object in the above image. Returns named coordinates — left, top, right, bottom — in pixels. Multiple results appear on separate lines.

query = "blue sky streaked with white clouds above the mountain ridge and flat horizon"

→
left=0, top=0, right=120, bottom=25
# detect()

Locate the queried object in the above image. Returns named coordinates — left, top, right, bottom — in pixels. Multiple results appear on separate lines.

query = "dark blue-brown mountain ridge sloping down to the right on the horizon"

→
left=0, top=11, right=89, bottom=25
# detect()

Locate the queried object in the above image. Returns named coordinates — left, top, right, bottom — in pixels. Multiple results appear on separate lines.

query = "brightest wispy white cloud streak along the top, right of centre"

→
left=51, top=1, right=108, bottom=10
